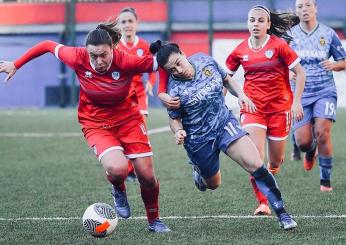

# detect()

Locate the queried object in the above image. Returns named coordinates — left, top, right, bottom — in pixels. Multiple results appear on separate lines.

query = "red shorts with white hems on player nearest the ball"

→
left=82, top=118, right=153, bottom=161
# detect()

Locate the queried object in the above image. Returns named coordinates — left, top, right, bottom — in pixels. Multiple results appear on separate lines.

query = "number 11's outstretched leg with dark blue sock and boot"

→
left=226, top=136, right=297, bottom=230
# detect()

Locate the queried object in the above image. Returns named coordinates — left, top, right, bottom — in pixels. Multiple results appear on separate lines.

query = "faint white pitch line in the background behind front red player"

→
left=0, top=126, right=170, bottom=138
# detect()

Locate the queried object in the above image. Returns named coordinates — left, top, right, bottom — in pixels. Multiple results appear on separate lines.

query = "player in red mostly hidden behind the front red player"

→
left=117, top=8, right=156, bottom=181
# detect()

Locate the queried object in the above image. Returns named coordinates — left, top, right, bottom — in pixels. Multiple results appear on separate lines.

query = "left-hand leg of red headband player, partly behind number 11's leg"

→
left=241, top=113, right=271, bottom=215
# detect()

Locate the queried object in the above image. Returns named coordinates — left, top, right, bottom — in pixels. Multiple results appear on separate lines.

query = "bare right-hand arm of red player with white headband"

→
left=291, top=63, right=305, bottom=121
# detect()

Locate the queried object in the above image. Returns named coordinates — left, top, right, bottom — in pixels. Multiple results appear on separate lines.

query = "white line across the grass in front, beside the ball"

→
left=0, top=214, right=346, bottom=221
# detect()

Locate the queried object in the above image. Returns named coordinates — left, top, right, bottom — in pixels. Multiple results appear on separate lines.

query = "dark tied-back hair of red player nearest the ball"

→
left=85, top=21, right=121, bottom=47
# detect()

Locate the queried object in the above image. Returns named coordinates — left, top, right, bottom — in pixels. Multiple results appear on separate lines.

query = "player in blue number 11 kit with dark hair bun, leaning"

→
left=150, top=41, right=297, bottom=229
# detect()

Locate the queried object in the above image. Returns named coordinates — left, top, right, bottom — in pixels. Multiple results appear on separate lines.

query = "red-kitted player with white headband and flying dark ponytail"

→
left=226, top=6, right=305, bottom=215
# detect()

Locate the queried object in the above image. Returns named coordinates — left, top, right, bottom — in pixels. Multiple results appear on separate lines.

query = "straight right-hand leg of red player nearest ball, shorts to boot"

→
left=120, top=120, right=170, bottom=233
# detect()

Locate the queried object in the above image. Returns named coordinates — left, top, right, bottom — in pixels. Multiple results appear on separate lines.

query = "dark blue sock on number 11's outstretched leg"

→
left=251, top=166, right=286, bottom=217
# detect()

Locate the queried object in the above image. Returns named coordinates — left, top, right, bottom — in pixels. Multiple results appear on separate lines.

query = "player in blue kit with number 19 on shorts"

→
left=291, top=0, right=346, bottom=191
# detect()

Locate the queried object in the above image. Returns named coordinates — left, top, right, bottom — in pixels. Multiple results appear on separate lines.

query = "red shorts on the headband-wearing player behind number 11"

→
left=240, top=110, right=292, bottom=141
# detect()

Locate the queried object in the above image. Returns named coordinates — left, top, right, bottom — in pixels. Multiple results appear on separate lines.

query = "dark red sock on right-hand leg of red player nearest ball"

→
left=141, top=180, right=160, bottom=223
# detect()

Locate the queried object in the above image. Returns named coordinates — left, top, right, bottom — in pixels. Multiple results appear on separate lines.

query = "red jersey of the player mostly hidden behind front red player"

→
left=117, top=36, right=156, bottom=87
